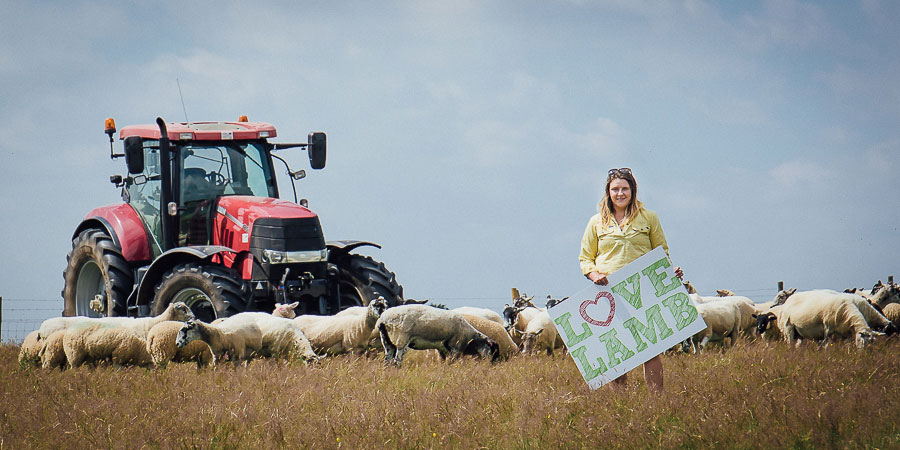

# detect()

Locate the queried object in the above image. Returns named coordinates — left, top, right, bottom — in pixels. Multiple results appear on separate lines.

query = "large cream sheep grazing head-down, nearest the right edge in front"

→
left=779, top=289, right=878, bottom=348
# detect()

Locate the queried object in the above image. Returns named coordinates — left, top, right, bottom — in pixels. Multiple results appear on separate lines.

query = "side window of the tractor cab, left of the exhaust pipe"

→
left=125, top=140, right=162, bottom=258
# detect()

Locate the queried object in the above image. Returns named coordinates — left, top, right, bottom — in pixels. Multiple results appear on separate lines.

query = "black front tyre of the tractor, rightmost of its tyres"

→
left=338, top=254, right=403, bottom=309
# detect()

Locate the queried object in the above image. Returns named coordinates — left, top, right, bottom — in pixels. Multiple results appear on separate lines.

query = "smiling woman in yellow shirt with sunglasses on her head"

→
left=578, top=167, right=684, bottom=392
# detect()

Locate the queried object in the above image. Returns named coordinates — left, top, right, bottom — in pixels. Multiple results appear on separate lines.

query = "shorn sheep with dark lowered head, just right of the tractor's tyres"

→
left=375, top=305, right=500, bottom=367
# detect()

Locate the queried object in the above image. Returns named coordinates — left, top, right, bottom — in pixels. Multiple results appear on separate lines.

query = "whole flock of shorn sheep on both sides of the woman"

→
left=19, top=282, right=900, bottom=369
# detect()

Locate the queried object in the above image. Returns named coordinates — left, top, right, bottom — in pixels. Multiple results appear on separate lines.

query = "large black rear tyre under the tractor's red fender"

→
left=62, top=228, right=134, bottom=317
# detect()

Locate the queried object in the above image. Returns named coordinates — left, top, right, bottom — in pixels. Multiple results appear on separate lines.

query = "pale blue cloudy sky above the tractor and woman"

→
left=0, top=0, right=900, bottom=330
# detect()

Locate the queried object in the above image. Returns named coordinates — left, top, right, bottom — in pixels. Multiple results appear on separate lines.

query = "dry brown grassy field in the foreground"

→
left=0, top=338, right=900, bottom=449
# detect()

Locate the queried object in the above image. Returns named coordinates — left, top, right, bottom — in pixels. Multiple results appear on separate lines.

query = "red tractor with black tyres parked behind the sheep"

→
left=62, top=116, right=403, bottom=322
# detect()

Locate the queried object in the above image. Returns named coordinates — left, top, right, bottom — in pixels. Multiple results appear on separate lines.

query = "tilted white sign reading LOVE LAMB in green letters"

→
left=548, top=247, right=706, bottom=389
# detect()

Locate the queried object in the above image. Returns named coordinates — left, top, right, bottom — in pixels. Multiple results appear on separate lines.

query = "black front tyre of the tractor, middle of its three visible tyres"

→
left=150, top=262, right=244, bottom=323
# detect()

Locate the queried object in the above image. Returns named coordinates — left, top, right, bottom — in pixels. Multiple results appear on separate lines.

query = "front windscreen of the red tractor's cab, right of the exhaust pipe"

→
left=178, top=142, right=276, bottom=245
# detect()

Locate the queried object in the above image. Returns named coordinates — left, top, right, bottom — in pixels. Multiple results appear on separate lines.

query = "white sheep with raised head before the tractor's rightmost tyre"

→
left=294, top=297, right=387, bottom=355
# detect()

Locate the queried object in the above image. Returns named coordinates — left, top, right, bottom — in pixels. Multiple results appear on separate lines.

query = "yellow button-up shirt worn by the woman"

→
left=578, top=208, right=669, bottom=275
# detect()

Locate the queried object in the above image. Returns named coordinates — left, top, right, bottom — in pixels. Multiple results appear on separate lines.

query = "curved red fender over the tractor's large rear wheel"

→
left=72, top=203, right=151, bottom=263
